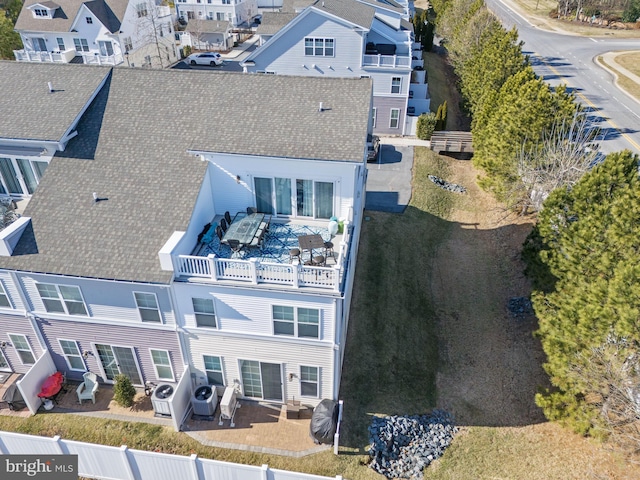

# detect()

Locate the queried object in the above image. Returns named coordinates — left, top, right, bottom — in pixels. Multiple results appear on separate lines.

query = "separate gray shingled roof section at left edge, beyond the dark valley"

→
left=0, top=61, right=109, bottom=142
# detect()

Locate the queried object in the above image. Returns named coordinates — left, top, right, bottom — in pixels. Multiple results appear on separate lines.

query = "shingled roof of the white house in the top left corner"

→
left=15, top=0, right=129, bottom=32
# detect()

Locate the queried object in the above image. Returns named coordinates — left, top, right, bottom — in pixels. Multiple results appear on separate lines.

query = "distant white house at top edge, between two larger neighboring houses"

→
left=176, top=0, right=258, bottom=28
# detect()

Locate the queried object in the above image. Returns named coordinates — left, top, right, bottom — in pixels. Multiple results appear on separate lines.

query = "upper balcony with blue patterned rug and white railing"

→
left=171, top=218, right=352, bottom=293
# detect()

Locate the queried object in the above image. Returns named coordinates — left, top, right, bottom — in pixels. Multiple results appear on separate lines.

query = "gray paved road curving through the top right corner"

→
left=486, top=0, right=640, bottom=153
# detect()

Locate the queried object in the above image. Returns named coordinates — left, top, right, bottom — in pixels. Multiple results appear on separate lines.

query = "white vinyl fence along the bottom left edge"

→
left=0, top=431, right=342, bottom=480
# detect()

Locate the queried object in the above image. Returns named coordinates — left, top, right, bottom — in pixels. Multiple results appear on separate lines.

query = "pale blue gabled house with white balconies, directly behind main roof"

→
left=242, top=0, right=429, bottom=135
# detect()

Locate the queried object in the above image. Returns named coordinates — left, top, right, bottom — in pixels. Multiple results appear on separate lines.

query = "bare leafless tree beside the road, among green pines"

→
left=509, top=112, right=602, bottom=213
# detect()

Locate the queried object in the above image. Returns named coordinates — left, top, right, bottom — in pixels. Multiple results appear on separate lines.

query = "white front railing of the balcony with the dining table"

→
left=173, top=255, right=342, bottom=292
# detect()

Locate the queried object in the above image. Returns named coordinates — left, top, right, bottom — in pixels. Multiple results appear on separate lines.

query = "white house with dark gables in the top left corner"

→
left=14, top=0, right=177, bottom=67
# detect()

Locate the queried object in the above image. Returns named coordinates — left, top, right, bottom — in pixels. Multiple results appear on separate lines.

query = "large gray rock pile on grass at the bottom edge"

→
left=369, top=410, right=457, bottom=479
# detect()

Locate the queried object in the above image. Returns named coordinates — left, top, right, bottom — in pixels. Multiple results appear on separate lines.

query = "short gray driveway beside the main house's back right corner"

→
left=365, top=137, right=420, bottom=213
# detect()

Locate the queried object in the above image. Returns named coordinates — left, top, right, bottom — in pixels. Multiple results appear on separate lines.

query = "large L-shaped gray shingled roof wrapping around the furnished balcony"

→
left=0, top=68, right=372, bottom=283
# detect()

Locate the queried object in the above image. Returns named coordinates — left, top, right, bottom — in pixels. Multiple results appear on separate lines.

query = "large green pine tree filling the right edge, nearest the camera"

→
left=525, top=151, right=640, bottom=438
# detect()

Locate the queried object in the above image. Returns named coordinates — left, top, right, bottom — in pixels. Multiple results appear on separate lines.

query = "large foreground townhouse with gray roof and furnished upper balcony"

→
left=0, top=63, right=372, bottom=414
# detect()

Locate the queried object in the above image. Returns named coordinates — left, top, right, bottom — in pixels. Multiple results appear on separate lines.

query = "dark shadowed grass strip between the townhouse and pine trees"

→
left=340, top=206, right=547, bottom=453
